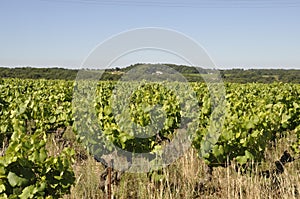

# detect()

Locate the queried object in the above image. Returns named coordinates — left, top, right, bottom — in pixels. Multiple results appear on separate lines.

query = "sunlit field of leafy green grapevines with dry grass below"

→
left=0, top=79, right=300, bottom=199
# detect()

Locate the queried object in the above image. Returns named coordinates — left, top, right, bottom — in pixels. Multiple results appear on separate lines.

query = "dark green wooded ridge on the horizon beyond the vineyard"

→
left=0, top=64, right=300, bottom=83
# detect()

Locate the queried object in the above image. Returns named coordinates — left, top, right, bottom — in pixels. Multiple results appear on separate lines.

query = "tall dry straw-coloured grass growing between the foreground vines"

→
left=48, top=130, right=300, bottom=199
